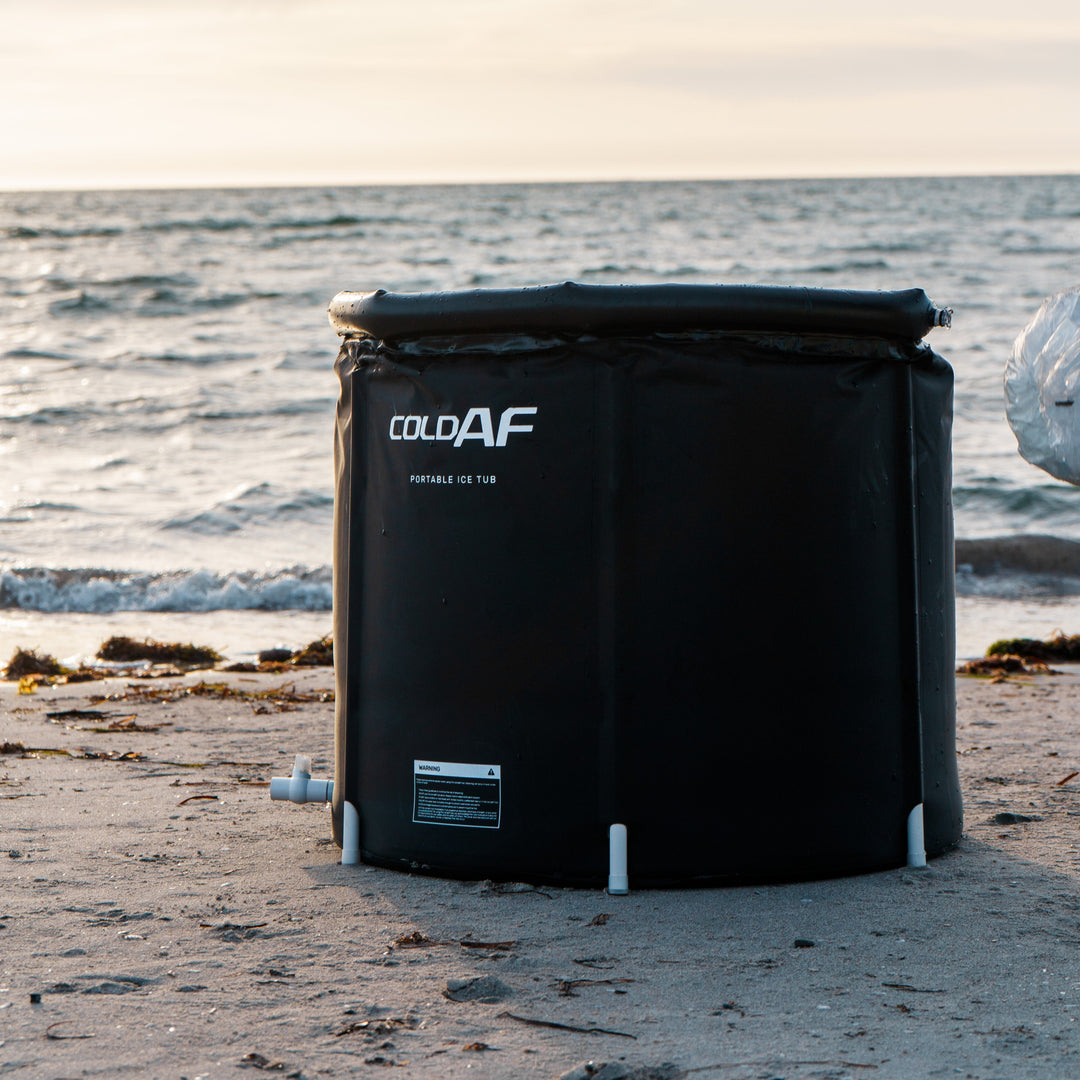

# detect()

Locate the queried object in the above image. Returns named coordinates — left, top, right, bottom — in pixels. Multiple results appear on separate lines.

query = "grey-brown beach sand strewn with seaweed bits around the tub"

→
left=6, top=669, right=1080, bottom=1080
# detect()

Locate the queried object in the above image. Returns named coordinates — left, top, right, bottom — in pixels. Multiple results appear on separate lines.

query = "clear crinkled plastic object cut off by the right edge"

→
left=1004, top=286, right=1080, bottom=485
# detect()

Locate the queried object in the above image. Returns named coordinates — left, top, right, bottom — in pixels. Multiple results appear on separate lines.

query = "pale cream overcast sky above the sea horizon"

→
left=0, top=0, right=1080, bottom=189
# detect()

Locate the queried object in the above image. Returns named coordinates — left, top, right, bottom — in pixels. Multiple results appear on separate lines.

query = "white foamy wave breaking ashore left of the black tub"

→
left=0, top=566, right=333, bottom=615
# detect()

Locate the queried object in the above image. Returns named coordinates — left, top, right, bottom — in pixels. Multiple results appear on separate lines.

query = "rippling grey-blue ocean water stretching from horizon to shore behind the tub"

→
left=0, top=176, right=1080, bottom=661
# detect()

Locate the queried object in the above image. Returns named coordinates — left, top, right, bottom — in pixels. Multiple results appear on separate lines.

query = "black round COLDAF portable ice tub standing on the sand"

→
left=330, top=284, right=961, bottom=887
